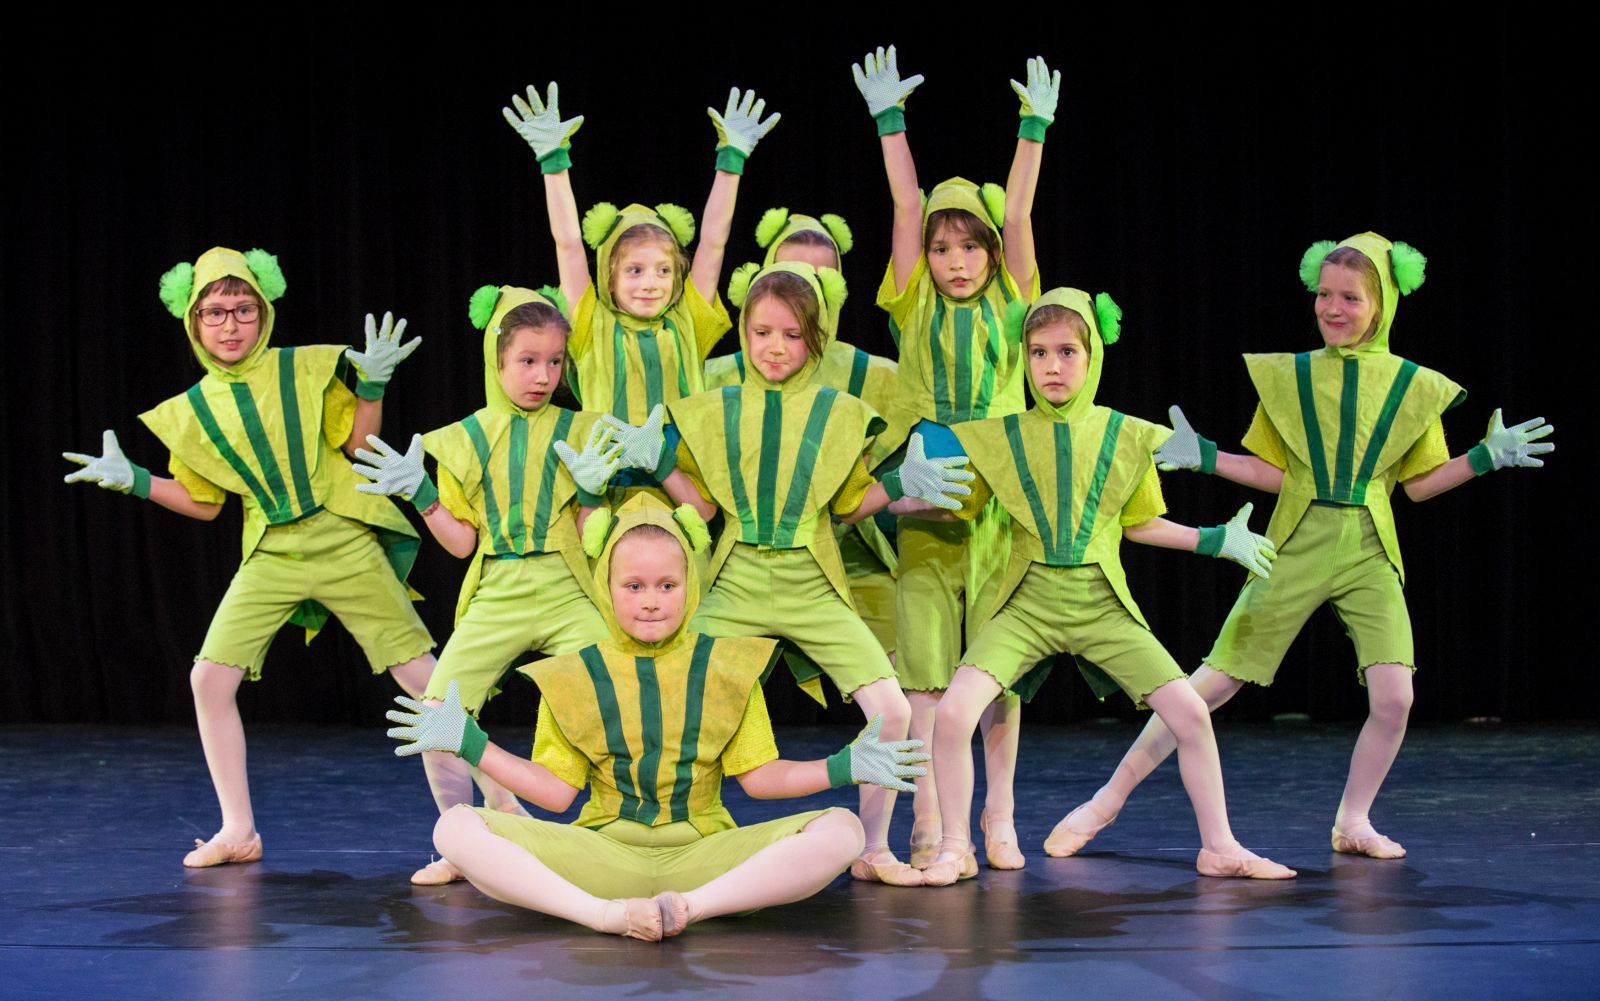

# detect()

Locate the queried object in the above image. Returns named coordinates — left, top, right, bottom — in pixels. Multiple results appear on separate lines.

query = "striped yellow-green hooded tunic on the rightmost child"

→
left=1245, top=233, right=1467, bottom=582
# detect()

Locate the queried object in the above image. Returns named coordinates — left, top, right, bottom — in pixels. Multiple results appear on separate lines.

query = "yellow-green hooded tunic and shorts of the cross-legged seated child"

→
left=480, top=494, right=821, bottom=897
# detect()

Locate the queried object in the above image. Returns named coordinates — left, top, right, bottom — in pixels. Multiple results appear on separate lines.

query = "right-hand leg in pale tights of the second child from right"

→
left=1144, top=681, right=1294, bottom=879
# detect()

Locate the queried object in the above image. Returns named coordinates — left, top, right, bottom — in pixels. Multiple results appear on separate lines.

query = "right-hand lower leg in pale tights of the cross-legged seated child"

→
left=683, top=809, right=864, bottom=923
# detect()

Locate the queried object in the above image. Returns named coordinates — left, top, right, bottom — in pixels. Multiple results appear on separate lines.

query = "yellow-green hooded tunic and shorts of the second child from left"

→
left=422, top=286, right=605, bottom=710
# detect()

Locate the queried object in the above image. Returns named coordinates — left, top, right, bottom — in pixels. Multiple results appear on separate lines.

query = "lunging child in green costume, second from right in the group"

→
left=923, top=288, right=1294, bottom=886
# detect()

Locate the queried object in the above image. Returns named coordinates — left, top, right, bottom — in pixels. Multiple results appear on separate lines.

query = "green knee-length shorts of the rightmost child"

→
left=1205, top=504, right=1416, bottom=684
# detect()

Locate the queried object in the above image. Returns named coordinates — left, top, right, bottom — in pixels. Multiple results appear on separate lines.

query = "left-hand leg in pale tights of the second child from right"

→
left=923, top=664, right=1000, bottom=886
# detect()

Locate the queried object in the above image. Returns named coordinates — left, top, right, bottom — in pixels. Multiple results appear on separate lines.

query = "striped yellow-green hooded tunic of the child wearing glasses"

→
left=139, top=248, right=421, bottom=638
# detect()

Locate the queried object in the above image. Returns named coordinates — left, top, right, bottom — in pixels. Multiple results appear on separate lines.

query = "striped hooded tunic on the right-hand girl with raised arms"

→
left=874, top=177, right=1038, bottom=461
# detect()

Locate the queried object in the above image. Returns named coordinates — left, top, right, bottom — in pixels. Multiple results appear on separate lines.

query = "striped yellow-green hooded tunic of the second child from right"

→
left=952, top=288, right=1171, bottom=699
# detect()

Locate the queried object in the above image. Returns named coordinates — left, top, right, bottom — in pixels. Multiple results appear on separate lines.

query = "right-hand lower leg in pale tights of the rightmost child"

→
left=1333, top=664, right=1411, bottom=859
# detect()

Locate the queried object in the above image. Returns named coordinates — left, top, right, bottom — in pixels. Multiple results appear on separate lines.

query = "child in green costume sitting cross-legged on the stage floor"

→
left=389, top=496, right=926, bottom=942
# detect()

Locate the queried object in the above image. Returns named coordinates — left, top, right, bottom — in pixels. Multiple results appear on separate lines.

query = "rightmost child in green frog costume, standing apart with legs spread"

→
left=1045, top=233, right=1555, bottom=859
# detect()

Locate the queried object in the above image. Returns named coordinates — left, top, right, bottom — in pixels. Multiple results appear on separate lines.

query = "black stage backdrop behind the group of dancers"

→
left=0, top=19, right=1595, bottom=724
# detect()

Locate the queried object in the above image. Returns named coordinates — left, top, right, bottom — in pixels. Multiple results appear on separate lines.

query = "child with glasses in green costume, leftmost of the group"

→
left=66, top=248, right=444, bottom=867
